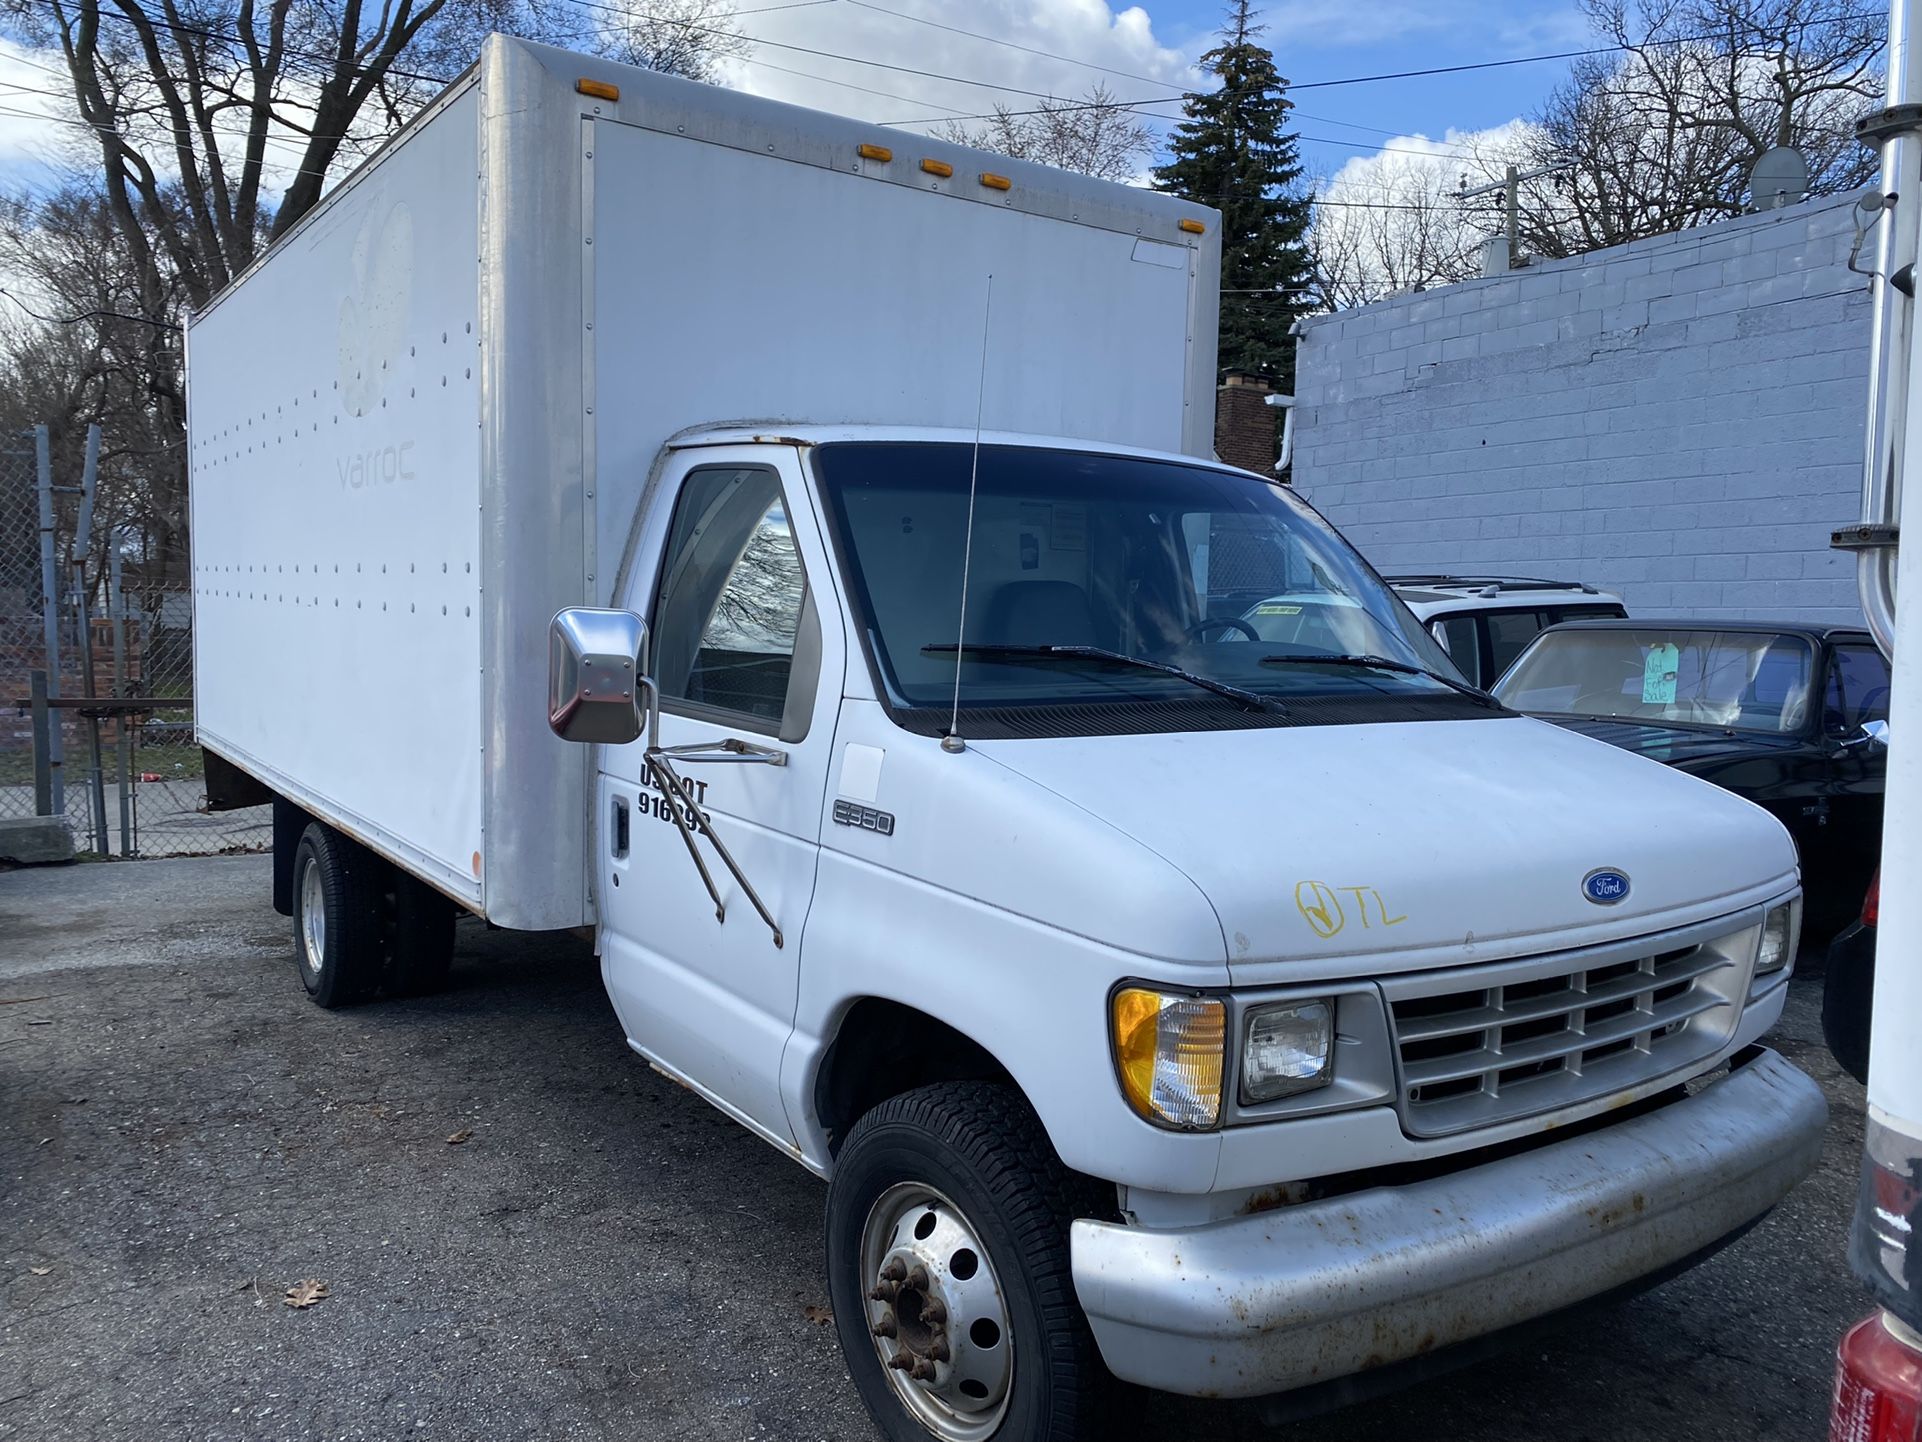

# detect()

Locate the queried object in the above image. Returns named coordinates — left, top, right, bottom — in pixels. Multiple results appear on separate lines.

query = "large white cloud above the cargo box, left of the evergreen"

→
left=723, top=0, right=1197, bottom=132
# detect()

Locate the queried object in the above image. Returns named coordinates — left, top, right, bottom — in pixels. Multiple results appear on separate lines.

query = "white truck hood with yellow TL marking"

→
left=971, top=717, right=1795, bottom=982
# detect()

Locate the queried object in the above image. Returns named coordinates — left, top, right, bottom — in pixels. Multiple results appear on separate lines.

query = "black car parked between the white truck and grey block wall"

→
left=1495, top=619, right=1889, bottom=938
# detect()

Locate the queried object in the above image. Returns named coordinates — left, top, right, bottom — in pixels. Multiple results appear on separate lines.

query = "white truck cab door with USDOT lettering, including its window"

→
left=598, top=446, right=844, bottom=1142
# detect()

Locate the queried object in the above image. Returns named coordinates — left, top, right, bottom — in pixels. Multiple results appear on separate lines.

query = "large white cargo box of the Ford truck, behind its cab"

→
left=188, top=37, right=1219, bottom=929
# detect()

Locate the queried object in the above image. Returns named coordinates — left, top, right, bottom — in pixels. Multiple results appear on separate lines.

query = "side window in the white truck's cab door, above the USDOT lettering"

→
left=652, top=467, right=821, bottom=740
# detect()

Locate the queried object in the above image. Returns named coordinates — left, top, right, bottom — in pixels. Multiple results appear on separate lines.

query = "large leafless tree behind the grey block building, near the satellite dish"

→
left=1522, top=0, right=1885, bottom=256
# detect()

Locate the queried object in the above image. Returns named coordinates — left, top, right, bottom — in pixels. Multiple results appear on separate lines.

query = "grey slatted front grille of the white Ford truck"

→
left=1382, top=931, right=1747, bottom=1136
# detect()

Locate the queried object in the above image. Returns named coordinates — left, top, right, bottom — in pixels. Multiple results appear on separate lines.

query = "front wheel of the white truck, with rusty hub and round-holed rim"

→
left=826, top=1082, right=1111, bottom=1442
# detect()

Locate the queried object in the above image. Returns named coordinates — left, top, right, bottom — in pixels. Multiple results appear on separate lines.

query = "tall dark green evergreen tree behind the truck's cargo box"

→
left=1155, top=0, right=1311, bottom=390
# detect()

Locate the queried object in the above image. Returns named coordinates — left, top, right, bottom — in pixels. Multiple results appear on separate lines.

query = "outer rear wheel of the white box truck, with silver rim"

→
left=292, top=821, right=386, bottom=1009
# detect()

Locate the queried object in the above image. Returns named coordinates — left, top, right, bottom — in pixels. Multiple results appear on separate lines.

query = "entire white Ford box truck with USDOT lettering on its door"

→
left=188, top=38, right=1824, bottom=1440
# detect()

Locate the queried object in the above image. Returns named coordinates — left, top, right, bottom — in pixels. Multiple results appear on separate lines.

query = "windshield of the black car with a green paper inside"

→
left=1495, top=627, right=1814, bottom=733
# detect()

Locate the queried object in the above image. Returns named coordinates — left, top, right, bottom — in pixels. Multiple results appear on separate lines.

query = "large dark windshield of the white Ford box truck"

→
left=813, top=442, right=1466, bottom=713
